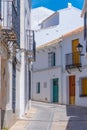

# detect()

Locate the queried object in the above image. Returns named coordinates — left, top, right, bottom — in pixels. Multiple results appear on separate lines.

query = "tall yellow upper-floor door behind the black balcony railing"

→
left=72, top=39, right=80, bottom=64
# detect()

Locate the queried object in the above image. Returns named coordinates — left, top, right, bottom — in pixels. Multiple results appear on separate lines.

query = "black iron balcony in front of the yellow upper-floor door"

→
left=65, top=52, right=82, bottom=73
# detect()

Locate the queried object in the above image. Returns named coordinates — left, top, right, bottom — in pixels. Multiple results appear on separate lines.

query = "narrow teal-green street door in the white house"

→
left=53, top=79, right=58, bottom=102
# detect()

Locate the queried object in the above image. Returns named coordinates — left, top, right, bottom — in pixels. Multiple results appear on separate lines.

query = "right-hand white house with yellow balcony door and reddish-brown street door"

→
left=61, top=27, right=87, bottom=106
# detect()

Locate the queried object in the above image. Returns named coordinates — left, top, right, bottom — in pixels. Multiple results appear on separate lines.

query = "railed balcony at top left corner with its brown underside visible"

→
left=0, top=1, right=20, bottom=43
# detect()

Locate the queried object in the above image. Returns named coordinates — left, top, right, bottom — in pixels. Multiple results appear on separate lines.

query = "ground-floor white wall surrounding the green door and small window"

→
left=32, top=68, right=61, bottom=102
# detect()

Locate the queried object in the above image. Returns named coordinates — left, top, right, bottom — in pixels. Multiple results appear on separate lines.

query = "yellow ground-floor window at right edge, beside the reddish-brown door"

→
left=81, top=78, right=87, bottom=96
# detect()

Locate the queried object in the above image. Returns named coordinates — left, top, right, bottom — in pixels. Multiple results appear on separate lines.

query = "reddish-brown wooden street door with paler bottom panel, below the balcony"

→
left=69, top=76, right=75, bottom=104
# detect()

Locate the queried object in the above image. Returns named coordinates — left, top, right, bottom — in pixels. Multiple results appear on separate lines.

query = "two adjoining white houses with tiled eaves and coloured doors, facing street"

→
left=32, top=27, right=87, bottom=106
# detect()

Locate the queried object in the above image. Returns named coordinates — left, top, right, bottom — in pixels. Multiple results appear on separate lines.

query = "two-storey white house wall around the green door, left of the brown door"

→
left=32, top=43, right=61, bottom=103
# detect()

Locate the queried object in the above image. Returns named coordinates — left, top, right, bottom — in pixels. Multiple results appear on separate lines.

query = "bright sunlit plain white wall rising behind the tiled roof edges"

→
left=35, top=7, right=84, bottom=46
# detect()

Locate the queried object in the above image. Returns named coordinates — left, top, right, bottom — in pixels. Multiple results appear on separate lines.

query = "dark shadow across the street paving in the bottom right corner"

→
left=66, top=106, right=87, bottom=130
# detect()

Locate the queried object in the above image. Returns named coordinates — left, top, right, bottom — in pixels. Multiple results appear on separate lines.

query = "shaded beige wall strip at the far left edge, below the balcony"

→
left=0, top=57, right=7, bottom=128
